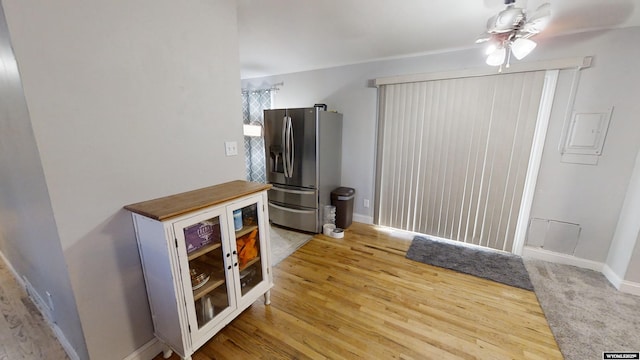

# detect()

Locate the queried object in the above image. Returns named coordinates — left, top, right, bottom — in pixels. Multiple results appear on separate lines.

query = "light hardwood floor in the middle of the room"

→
left=156, top=223, right=562, bottom=360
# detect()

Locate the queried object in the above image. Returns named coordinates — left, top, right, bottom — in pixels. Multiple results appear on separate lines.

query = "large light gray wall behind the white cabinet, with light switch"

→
left=4, top=0, right=244, bottom=359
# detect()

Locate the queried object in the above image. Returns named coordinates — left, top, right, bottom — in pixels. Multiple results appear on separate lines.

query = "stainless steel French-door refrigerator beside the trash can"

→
left=264, top=107, right=342, bottom=233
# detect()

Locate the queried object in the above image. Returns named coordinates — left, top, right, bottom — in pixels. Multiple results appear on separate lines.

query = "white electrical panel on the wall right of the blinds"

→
left=560, top=107, right=613, bottom=165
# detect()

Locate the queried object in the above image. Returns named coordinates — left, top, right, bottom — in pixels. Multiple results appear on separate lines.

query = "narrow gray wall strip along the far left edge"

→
left=0, top=6, right=87, bottom=358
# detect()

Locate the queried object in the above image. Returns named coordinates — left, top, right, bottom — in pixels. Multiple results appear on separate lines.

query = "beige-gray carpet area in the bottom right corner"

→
left=525, top=259, right=640, bottom=360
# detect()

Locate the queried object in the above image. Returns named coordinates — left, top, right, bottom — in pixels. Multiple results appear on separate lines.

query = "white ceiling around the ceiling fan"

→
left=238, top=0, right=640, bottom=78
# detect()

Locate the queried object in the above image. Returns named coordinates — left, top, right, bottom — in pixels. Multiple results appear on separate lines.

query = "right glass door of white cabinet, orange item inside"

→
left=232, top=198, right=268, bottom=296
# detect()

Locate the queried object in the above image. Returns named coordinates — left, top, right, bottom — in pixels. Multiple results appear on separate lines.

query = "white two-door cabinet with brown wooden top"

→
left=125, top=181, right=273, bottom=359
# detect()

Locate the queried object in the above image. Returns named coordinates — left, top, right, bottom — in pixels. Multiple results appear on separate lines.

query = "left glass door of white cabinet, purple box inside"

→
left=175, top=213, right=235, bottom=329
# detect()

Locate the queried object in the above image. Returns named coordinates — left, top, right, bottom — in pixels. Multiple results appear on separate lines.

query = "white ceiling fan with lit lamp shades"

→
left=476, top=0, right=551, bottom=70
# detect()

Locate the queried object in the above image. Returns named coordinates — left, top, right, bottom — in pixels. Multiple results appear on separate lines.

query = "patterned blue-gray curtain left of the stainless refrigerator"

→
left=242, top=89, right=273, bottom=183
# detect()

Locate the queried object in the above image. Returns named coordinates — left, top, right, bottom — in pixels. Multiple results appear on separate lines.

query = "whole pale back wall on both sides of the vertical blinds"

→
left=243, top=28, right=640, bottom=262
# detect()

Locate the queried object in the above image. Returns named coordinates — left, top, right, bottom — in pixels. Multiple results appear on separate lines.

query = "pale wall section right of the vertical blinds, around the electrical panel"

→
left=532, top=28, right=640, bottom=262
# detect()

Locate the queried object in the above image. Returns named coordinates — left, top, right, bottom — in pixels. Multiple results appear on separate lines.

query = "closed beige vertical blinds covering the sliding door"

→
left=375, top=71, right=545, bottom=251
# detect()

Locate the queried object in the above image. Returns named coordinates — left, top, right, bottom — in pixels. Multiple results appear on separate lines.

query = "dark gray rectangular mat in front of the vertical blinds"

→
left=406, top=236, right=533, bottom=290
